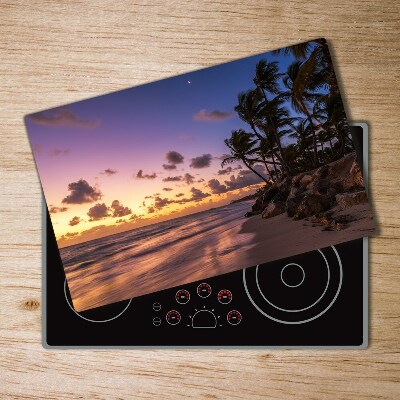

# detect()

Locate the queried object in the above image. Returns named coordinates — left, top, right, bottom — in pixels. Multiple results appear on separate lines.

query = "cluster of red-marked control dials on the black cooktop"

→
left=153, top=282, right=242, bottom=329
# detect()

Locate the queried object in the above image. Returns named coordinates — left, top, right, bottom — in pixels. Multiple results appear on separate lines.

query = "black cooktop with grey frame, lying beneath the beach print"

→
left=43, top=124, right=368, bottom=348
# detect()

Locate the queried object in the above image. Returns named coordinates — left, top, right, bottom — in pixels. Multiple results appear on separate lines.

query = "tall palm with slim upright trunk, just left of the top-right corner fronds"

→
left=281, top=61, right=320, bottom=167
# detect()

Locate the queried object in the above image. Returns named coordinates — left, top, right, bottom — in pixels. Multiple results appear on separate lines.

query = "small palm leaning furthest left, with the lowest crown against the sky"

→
left=221, top=129, right=268, bottom=183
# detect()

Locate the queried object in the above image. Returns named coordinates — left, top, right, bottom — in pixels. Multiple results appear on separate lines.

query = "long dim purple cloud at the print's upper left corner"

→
left=27, top=107, right=100, bottom=129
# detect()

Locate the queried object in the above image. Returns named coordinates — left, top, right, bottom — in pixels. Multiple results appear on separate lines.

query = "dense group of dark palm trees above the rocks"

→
left=222, top=39, right=354, bottom=182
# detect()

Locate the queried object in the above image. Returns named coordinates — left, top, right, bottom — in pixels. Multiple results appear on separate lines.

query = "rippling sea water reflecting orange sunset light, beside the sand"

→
left=60, top=201, right=254, bottom=311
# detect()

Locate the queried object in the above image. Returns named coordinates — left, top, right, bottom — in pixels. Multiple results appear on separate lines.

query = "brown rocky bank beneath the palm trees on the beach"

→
left=246, top=153, right=367, bottom=223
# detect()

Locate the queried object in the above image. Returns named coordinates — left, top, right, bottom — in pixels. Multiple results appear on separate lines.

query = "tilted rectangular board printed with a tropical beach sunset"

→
left=25, top=40, right=373, bottom=311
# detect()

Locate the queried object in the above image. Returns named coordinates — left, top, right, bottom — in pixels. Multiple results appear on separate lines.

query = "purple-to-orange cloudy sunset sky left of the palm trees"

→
left=26, top=43, right=302, bottom=246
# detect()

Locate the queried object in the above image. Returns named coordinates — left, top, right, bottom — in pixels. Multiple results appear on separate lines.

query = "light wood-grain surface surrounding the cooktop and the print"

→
left=0, top=0, right=400, bottom=400
